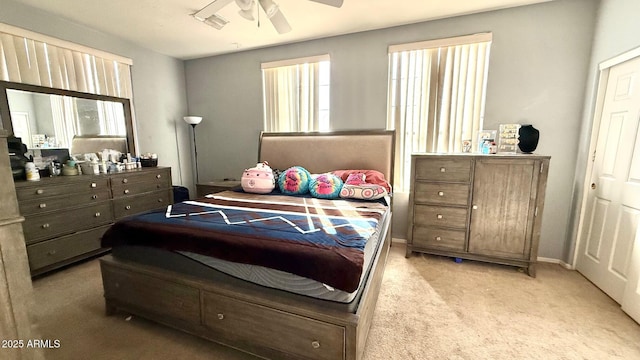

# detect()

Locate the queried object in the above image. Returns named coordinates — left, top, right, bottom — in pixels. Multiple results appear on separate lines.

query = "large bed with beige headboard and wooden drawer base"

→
left=100, top=130, right=394, bottom=360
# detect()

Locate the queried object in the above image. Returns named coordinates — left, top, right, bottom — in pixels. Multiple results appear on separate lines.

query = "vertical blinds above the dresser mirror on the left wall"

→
left=0, top=24, right=133, bottom=99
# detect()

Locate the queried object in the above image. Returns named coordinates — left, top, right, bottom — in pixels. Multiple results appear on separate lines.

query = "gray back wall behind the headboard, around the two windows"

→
left=185, top=0, right=599, bottom=259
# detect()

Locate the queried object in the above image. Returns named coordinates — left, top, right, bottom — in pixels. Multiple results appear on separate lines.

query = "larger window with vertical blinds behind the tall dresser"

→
left=387, top=33, right=491, bottom=191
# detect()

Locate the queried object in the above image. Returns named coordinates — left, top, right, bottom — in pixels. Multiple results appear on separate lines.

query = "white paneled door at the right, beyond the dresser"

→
left=576, top=54, right=640, bottom=321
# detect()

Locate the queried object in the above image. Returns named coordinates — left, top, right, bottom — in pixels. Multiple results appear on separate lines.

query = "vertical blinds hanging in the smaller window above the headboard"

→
left=262, top=62, right=320, bottom=132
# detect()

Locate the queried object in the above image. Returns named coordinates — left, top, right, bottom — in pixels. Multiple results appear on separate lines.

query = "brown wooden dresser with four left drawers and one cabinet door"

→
left=407, top=154, right=550, bottom=276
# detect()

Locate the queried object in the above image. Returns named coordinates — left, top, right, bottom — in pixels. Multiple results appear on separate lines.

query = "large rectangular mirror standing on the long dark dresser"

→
left=0, top=81, right=136, bottom=154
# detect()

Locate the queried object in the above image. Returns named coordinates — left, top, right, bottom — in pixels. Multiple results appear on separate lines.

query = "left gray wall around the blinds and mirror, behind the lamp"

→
left=0, top=0, right=193, bottom=193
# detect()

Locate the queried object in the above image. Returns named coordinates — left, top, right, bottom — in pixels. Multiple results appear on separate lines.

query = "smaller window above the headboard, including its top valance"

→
left=262, top=55, right=330, bottom=132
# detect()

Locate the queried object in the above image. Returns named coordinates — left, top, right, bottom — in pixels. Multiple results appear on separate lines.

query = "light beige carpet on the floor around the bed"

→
left=27, top=244, right=640, bottom=360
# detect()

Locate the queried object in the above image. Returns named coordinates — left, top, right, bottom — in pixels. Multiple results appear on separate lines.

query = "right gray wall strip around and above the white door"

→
left=563, top=0, right=640, bottom=260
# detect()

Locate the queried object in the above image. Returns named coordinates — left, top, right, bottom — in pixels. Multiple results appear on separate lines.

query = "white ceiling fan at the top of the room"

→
left=192, top=0, right=344, bottom=34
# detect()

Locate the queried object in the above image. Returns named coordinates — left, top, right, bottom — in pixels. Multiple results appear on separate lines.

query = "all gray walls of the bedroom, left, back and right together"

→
left=0, top=0, right=620, bottom=262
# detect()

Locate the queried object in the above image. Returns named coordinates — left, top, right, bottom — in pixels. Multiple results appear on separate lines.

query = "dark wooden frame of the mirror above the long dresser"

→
left=0, top=80, right=138, bottom=154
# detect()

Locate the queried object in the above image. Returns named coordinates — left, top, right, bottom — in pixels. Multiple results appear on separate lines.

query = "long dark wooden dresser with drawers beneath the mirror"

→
left=15, top=167, right=173, bottom=276
